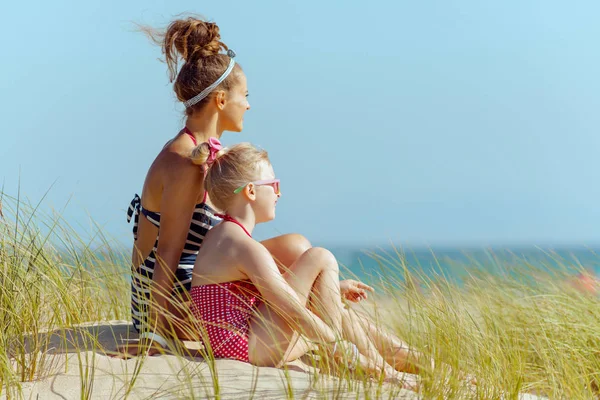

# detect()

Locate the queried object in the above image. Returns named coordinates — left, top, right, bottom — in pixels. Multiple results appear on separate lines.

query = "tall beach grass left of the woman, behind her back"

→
left=0, top=193, right=128, bottom=398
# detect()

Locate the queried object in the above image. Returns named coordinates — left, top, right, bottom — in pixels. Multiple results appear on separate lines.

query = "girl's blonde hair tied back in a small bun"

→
left=191, top=143, right=271, bottom=211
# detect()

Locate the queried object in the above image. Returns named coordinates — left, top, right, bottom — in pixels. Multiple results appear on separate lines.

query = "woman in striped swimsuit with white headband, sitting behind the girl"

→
left=120, top=17, right=370, bottom=355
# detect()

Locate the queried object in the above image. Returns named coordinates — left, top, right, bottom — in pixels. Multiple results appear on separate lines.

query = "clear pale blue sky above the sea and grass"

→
left=0, top=0, right=600, bottom=246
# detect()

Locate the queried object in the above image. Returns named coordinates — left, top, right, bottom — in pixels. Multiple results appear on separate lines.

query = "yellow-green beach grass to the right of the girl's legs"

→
left=360, top=245, right=600, bottom=399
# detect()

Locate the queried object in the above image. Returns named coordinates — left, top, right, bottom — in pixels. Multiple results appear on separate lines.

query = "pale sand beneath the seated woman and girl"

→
left=0, top=304, right=548, bottom=400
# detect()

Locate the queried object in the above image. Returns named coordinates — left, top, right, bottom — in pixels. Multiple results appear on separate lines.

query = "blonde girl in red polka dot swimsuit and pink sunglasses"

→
left=185, top=141, right=424, bottom=377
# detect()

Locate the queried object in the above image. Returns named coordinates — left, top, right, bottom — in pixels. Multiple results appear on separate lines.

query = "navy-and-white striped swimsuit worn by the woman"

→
left=127, top=192, right=221, bottom=332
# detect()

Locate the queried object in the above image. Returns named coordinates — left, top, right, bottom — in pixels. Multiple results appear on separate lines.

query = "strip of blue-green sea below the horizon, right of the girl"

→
left=329, top=246, right=600, bottom=284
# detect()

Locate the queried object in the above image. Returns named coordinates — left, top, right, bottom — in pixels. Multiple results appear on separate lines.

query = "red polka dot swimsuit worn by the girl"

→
left=190, top=215, right=260, bottom=362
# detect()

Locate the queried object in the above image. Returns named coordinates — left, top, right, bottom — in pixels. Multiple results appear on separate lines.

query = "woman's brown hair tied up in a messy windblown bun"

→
left=140, top=17, right=242, bottom=115
